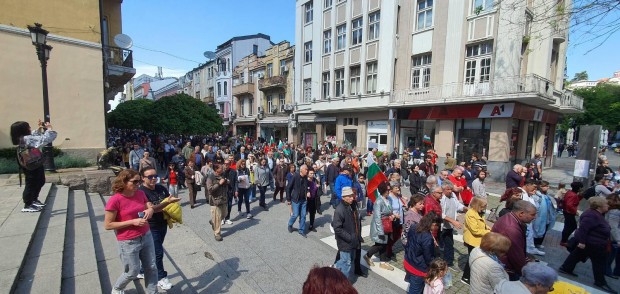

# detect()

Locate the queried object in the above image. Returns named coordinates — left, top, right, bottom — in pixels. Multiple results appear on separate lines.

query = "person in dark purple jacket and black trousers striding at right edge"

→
left=559, top=197, right=616, bottom=293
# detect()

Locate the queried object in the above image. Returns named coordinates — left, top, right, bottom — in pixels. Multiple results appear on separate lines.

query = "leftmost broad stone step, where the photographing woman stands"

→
left=0, top=184, right=56, bottom=293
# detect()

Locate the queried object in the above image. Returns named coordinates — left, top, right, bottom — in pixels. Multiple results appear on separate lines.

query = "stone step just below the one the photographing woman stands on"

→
left=15, top=186, right=69, bottom=293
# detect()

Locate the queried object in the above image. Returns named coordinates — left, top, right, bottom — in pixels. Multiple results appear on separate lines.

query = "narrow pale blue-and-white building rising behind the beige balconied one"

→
left=215, top=34, right=273, bottom=126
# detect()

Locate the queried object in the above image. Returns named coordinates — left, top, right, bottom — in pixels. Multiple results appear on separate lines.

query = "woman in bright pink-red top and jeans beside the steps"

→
left=104, top=169, right=157, bottom=293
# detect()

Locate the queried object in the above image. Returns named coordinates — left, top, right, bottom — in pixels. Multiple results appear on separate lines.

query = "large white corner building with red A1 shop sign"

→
left=296, top=0, right=583, bottom=176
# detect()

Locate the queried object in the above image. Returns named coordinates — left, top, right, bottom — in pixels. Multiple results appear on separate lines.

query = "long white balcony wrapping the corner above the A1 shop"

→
left=390, top=75, right=568, bottom=110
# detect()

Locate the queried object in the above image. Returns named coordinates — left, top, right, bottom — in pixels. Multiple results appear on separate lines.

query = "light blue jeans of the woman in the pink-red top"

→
left=114, top=231, right=158, bottom=293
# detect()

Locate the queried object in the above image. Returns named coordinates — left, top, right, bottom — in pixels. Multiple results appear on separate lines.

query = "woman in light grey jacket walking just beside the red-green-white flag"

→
left=364, top=182, right=396, bottom=271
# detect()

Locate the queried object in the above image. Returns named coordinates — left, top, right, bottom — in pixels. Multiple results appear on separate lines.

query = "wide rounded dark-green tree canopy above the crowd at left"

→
left=107, top=94, right=223, bottom=135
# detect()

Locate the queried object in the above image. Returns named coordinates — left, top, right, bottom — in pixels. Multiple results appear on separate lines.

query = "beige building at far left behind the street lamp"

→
left=0, top=0, right=136, bottom=158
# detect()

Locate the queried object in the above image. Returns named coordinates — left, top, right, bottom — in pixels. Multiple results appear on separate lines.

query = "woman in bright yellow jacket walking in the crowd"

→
left=461, top=197, right=491, bottom=284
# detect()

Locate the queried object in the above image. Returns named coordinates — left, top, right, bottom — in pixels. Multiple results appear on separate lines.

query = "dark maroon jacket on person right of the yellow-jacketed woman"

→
left=491, top=213, right=527, bottom=273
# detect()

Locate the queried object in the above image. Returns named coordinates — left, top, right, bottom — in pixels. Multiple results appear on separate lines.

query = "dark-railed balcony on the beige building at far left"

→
left=103, top=46, right=136, bottom=89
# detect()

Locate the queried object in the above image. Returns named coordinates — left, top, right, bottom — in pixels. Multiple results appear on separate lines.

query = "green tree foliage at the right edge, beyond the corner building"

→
left=560, top=84, right=620, bottom=131
